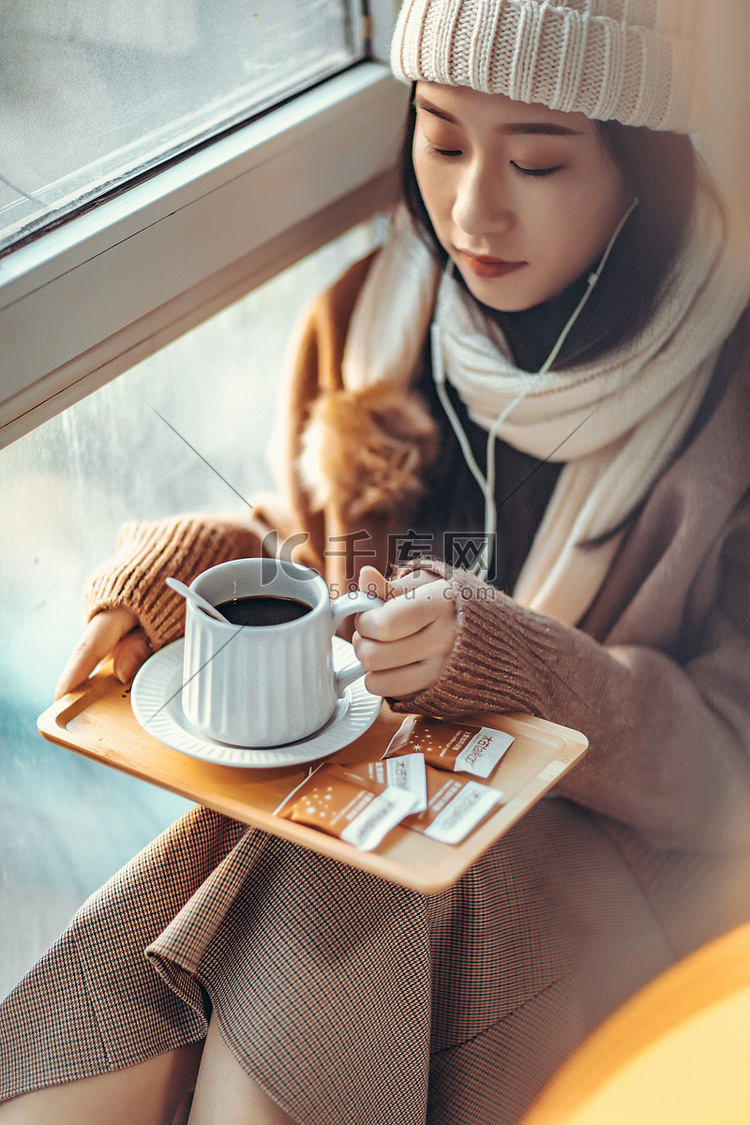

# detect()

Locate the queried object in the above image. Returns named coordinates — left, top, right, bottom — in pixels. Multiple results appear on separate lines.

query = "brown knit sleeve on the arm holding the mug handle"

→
left=390, top=553, right=750, bottom=852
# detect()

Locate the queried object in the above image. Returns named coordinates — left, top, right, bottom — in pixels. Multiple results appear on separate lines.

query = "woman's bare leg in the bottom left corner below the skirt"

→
left=0, top=1043, right=202, bottom=1125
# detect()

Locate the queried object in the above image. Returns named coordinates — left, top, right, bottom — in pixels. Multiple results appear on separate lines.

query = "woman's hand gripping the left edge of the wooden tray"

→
left=55, top=609, right=152, bottom=700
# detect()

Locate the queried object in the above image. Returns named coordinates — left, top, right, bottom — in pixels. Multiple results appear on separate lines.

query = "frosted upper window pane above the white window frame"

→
left=0, top=0, right=363, bottom=249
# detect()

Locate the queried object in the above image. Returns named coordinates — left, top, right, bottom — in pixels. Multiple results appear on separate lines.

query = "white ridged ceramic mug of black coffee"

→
left=182, top=558, right=383, bottom=747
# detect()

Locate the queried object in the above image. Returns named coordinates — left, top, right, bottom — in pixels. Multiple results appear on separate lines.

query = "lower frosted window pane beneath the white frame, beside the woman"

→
left=0, top=217, right=379, bottom=995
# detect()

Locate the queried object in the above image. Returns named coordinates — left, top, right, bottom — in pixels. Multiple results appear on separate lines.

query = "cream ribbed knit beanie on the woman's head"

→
left=391, top=0, right=706, bottom=133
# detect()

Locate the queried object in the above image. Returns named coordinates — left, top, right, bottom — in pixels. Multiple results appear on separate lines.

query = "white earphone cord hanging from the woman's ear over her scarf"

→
left=430, top=199, right=639, bottom=582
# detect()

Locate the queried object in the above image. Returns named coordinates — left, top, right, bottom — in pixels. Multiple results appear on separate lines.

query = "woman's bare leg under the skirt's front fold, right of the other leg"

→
left=190, top=1017, right=295, bottom=1125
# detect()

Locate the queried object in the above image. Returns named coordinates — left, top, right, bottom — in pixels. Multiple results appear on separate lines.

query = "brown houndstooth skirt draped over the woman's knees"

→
left=0, top=800, right=672, bottom=1125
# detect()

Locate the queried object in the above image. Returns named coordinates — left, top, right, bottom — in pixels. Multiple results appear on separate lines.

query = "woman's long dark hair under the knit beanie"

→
left=401, top=93, right=698, bottom=370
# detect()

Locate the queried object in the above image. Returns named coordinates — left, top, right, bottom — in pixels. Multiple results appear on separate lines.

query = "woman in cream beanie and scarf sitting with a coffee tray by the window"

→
left=0, top=0, right=750, bottom=1125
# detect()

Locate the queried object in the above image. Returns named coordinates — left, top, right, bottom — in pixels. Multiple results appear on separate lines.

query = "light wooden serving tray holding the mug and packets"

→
left=38, top=665, right=588, bottom=894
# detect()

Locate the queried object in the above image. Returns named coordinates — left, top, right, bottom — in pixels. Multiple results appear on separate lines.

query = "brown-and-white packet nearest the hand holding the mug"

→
left=383, top=714, right=514, bottom=779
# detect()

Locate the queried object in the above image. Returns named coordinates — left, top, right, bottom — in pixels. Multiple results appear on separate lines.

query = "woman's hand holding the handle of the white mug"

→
left=352, top=566, right=455, bottom=699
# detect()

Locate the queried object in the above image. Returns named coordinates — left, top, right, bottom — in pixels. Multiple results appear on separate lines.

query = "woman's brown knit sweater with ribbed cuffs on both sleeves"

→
left=87, top=250, right=750, bottom=855
